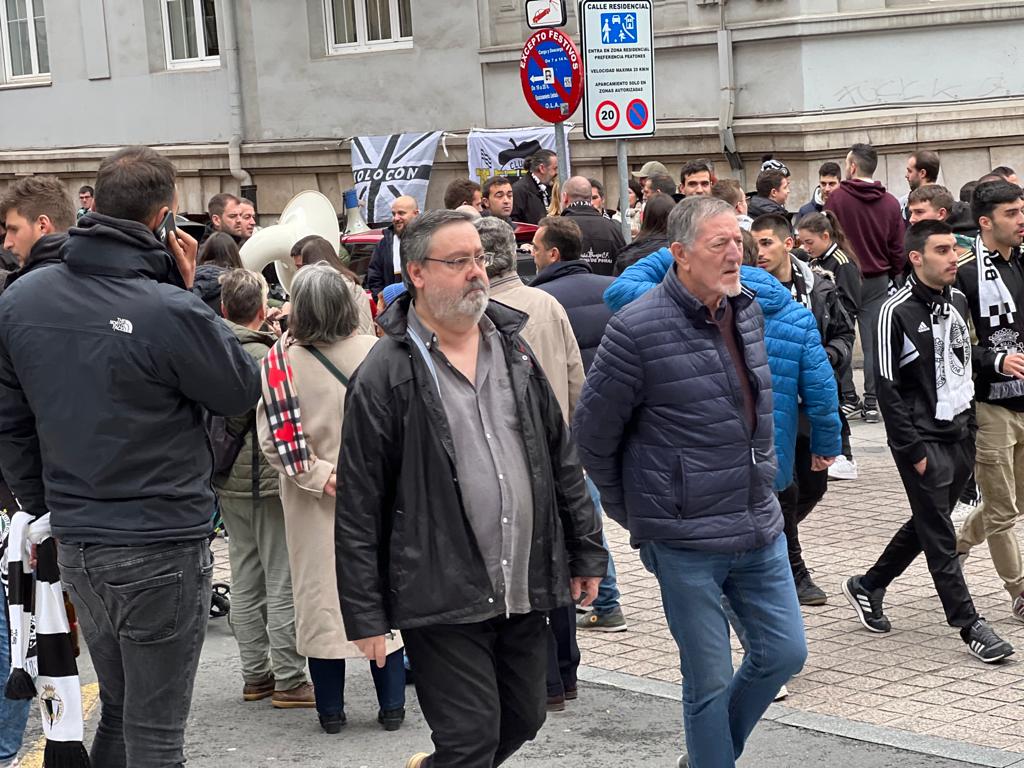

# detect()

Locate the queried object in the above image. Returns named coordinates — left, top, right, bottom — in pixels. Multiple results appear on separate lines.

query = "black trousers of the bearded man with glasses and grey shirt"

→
left=401, top=611, right=548, bottom=768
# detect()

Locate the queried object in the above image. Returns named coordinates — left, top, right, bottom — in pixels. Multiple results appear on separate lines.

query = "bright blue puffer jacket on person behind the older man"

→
left=604, top=248, right=842, bottom=490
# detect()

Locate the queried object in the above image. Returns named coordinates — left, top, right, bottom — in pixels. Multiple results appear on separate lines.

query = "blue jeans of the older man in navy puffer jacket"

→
left=640, top=535, right=807, bottom=768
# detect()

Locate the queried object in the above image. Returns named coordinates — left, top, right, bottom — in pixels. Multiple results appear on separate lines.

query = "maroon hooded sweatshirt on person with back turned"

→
left=825, top=178, right=906, bottom=278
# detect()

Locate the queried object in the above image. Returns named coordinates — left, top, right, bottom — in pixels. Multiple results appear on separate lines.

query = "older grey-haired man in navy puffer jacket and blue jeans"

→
left=573, top=198, right=807, bottom=768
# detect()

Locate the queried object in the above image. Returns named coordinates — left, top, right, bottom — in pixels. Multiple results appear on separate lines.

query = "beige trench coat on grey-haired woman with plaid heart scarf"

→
left=256, top=333, right=402, bottom=658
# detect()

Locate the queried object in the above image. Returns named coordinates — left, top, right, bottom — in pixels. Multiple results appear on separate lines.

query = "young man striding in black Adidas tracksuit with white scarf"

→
left=843, top=221, right=1014, bottom=663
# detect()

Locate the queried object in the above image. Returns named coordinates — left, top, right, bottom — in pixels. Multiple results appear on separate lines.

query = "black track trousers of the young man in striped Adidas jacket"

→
left=861, top=440, right=978, bottom=627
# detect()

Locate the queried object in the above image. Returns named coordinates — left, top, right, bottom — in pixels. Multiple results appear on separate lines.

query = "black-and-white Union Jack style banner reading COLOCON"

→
left=352, top=131, right=441, bottom=226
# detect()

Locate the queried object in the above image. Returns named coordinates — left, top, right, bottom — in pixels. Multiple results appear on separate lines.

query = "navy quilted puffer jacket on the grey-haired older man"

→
left=572, top=264, right=782, bottom=552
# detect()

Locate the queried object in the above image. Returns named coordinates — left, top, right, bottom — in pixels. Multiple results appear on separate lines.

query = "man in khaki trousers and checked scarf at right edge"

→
left=956, top=180, right=1024, bottom=622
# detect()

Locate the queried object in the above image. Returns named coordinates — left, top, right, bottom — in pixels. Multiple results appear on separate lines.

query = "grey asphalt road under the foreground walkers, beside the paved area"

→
left=176, top=622, right=983, bottom=768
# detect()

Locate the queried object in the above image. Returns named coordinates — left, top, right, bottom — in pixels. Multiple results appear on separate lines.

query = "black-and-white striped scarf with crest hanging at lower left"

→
left=0, top=512, right=89, bottom=768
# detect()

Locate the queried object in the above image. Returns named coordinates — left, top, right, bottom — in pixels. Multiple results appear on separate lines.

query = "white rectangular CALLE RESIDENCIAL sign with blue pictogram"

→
left=580, top=0, right=655, bottom=138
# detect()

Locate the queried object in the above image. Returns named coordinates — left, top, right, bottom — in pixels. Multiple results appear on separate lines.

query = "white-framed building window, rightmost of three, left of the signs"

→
left=326, top=0, right=413, bottom=53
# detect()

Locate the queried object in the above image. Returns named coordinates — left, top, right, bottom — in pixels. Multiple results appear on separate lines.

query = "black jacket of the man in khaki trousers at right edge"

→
left=956, top=244, right=1024, bottom=413
